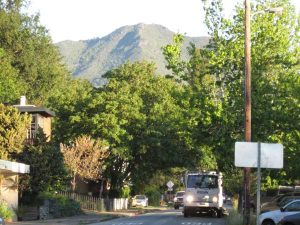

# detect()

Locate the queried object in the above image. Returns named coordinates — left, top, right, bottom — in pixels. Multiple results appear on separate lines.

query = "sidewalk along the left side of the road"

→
left=6, top=207, right=167, bottom=225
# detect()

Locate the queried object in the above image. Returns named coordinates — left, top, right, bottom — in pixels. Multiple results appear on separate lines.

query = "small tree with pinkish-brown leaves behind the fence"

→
left=60, top=136, right=108, bottom=192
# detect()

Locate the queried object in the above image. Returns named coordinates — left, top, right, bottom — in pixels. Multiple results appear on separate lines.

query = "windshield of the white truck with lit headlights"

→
left=187, top=174, right=218, bottom=188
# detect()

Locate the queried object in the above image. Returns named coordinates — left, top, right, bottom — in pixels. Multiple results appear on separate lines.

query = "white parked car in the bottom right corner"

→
left=259, top=199, right=300, bottom=225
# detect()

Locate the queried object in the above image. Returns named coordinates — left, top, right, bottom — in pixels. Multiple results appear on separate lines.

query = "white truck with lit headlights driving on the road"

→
left=183, top=171, right=224, bottom=217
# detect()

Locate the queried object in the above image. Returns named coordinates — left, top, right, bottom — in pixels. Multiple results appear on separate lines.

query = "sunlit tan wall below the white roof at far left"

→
left=0, top=175, right=18, bottom=208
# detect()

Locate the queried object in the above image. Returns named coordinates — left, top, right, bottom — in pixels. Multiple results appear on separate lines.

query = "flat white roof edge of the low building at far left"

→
left=0, top=159, right=30, bottom=174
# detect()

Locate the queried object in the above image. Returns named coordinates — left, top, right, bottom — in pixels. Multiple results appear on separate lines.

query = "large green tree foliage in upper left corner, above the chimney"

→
left=0, top=0, right=70, bottom=105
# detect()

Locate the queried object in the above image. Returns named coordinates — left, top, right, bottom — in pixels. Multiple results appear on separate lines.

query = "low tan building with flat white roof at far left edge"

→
left=0, top=160, right=30, bottom=209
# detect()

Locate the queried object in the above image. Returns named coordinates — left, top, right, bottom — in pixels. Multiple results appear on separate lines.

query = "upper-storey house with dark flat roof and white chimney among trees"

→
left=14, top=96, right=55, bottom=143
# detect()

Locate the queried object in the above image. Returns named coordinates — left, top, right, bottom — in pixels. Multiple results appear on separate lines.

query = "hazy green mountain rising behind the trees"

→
left=56, top=24, right=209, bottom=85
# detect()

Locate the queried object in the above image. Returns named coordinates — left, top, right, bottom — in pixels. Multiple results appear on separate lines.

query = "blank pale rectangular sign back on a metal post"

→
left=234, top=142, right=283, bottom=169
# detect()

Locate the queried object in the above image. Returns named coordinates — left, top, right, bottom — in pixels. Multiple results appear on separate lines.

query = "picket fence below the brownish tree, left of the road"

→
left=57, top=191, right=128, bottom=211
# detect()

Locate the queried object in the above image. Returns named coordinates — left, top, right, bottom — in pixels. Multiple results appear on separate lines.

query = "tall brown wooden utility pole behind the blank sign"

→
left=243, top=0, right=251, bottom=225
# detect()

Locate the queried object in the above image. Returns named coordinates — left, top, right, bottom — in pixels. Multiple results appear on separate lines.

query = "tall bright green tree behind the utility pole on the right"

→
left=202, top=0, right=300, bottom=185
